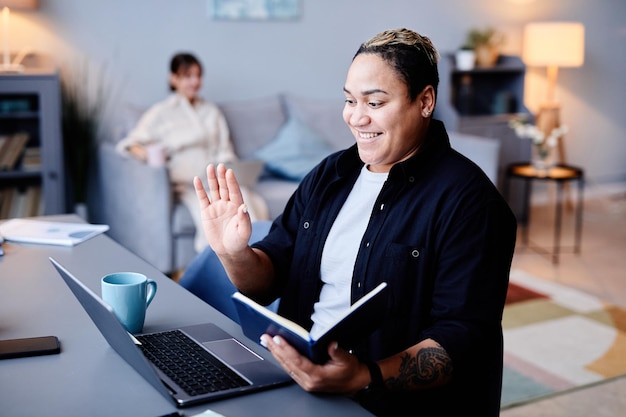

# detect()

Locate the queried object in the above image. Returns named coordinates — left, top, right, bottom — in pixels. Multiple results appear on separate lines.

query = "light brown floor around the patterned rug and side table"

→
left=500, top=183, right=626, bottom=417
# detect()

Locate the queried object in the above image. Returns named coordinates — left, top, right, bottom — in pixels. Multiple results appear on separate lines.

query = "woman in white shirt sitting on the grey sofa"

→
left=116, top=53, right=268, bottom=252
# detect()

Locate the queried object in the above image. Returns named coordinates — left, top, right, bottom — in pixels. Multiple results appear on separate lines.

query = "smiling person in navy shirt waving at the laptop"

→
left=194, top=29, right=516, bottom=417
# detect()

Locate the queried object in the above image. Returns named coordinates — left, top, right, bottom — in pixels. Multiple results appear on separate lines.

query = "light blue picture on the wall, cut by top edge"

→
left=207, top=0, right=300, bottom=20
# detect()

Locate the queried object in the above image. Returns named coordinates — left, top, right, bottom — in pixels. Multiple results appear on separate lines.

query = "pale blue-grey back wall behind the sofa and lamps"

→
left=11, top=0, right=626, bottom=182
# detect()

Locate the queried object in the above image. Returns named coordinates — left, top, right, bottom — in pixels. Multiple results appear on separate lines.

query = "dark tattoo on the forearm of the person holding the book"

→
left=386, top=347, right=452, bottom=390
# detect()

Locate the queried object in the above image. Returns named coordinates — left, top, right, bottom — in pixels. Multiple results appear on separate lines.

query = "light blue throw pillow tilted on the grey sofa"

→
left=254, top=117, right=334, bottom=181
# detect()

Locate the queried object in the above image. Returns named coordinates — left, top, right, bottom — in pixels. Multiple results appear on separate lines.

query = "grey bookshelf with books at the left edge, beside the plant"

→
left=0, top=70, right=66, bottom=219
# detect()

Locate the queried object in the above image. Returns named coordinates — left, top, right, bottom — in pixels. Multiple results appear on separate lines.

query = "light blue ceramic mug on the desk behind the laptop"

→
left=102, top=272, right=157, bottom=333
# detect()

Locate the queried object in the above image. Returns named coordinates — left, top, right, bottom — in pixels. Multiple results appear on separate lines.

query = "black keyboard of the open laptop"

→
left=135, top=330, right=250, bottom=396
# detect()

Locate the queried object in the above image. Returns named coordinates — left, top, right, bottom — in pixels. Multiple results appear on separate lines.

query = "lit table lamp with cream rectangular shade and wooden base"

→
left=522, top=22, right=585, bottom=162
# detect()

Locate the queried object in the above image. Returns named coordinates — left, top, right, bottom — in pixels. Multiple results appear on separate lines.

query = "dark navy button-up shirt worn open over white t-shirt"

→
left=254, top=120, right=516, bottom=416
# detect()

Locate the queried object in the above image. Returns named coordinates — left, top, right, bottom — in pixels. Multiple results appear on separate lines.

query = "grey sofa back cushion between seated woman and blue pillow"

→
left=218, top=94, right=287, bottom=159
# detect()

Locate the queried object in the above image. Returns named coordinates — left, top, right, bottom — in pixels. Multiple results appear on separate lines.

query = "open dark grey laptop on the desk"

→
left=49, top=258, right=292, bottom=407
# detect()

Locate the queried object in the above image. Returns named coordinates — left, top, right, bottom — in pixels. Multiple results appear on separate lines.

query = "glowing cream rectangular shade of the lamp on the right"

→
left=522, top=22, right=585, bottom=67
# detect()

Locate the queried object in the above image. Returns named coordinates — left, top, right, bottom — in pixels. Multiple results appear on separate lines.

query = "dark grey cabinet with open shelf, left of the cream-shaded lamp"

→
left=434, top=55, right=533, bottom=220
